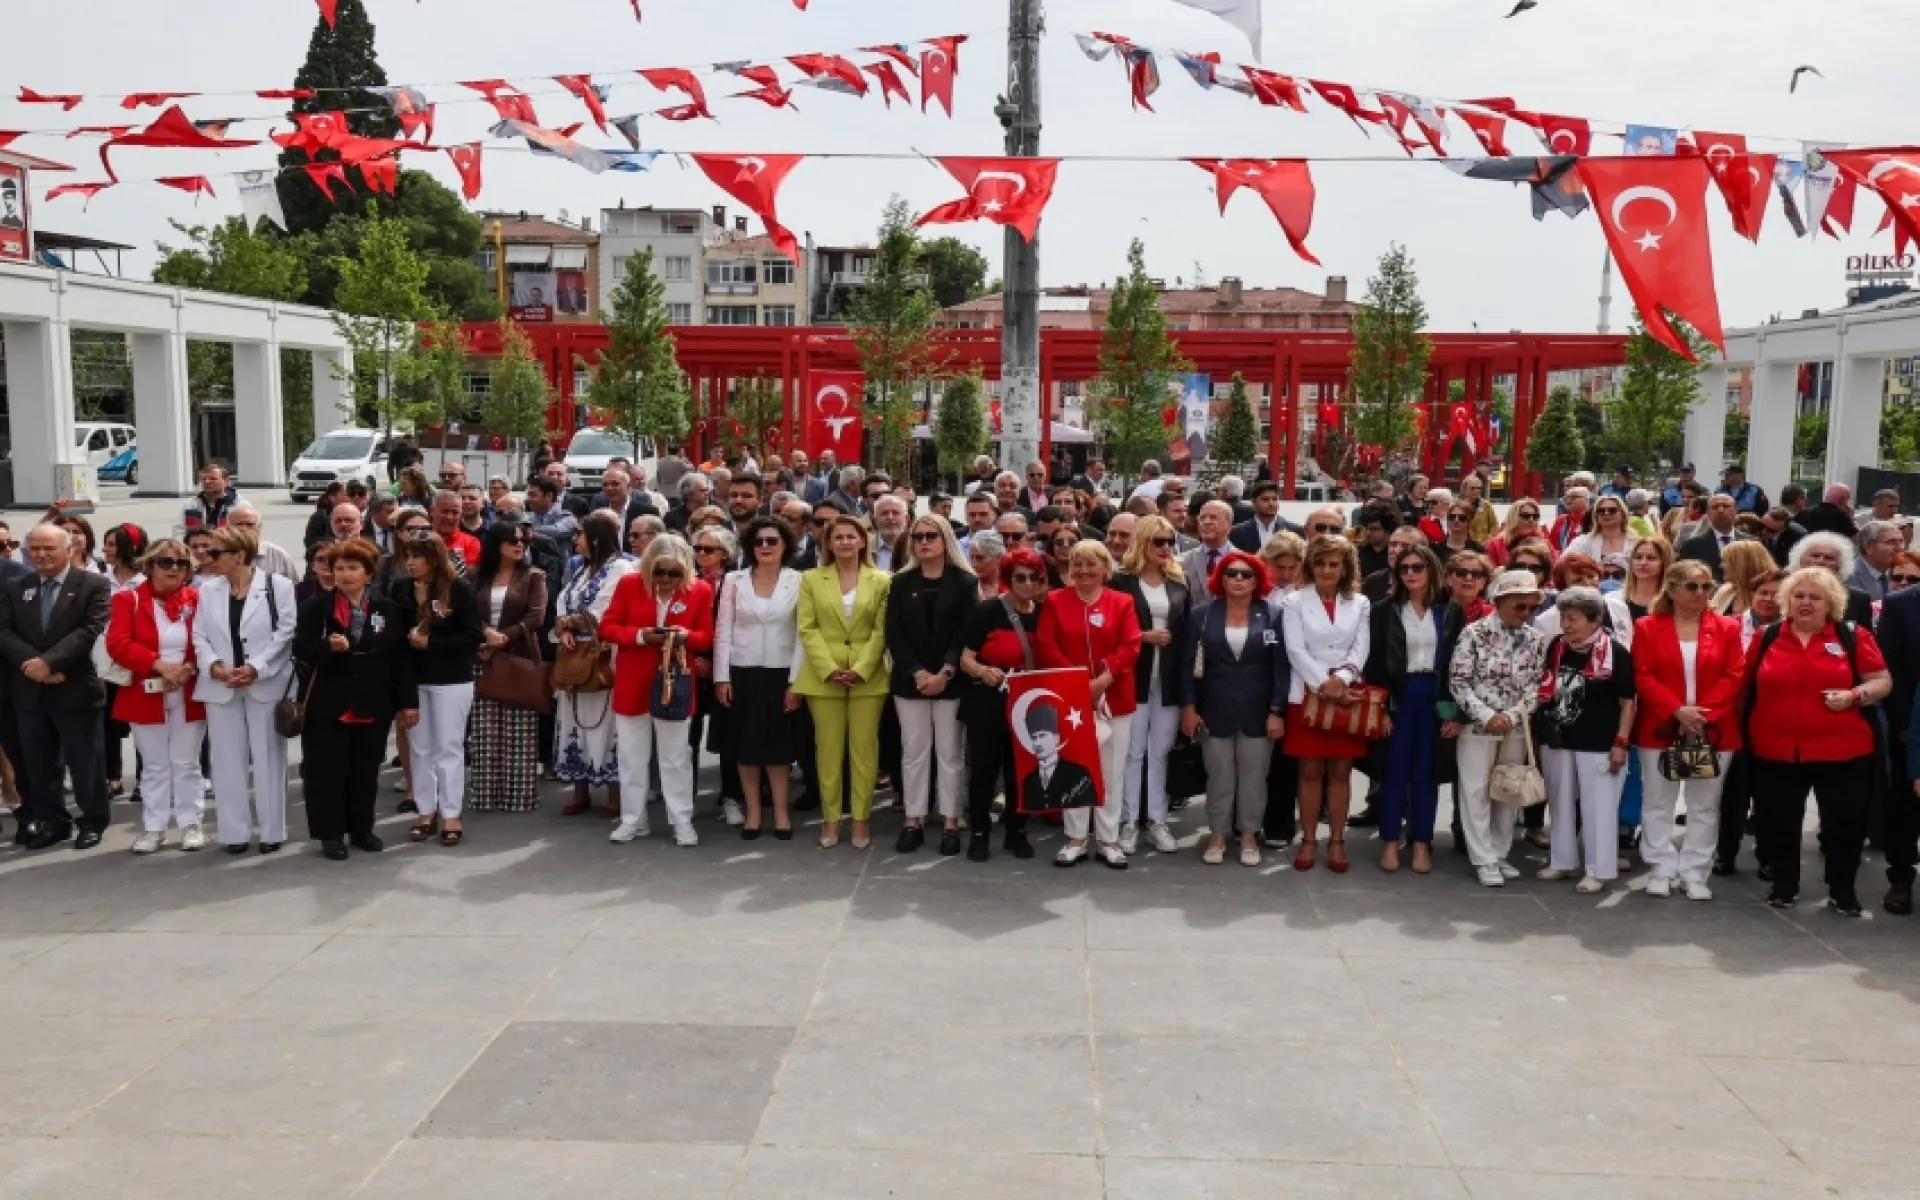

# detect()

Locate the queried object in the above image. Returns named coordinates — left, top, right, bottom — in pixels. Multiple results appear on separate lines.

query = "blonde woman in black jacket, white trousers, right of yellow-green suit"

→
left=887, top=514, right=979, bottom=856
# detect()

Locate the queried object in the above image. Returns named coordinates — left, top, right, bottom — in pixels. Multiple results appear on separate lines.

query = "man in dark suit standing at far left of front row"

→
left=0, top=524, right=109, bottom=851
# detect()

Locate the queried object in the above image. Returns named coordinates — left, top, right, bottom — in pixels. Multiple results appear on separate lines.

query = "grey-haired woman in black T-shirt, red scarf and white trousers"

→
left=1534, top=587, right=1634, bottom=893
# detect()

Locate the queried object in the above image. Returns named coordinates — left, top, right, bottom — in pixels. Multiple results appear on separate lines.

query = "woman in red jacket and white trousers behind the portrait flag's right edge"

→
left=1035, top=526, right=1140, bottom=870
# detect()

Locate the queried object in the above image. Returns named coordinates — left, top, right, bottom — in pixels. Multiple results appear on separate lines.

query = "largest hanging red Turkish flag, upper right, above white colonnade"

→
left=1576, top=157, right=1726, bottom=361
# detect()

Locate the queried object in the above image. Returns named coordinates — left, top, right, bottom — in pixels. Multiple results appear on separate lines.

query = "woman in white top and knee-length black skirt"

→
left=714, top=516, right=804, bottom=841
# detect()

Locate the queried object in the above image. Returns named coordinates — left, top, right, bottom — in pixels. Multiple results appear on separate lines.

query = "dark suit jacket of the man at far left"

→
left=0, top=566, right=111, bottom=712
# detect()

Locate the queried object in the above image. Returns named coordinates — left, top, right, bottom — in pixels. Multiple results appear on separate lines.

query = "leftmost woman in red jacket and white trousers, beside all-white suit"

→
left=106, top=538, right=210, bottom=854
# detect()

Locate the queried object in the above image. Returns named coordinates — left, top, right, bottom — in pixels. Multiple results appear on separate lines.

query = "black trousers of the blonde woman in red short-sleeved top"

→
left=1751, top=755, right=1874, bottom=897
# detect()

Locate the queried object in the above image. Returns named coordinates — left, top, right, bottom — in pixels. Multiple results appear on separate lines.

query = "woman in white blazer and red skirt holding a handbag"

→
left=1281, top=534, right=1371, bottom=876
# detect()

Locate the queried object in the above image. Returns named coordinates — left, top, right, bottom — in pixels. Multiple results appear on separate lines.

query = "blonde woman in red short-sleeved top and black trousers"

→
left=1745, top=566, right=1889, bottom=916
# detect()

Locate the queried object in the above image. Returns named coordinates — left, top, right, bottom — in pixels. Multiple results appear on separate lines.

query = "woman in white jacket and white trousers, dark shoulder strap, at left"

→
left=194, top=526, right=300, bottom=854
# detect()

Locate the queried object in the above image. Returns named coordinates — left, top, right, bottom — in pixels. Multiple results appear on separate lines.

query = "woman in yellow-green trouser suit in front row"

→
left=793, top=516, right=891, bottom=851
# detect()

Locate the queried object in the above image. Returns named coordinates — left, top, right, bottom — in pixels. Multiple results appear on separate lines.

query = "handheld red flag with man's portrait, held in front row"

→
left=1006, top=666, right=1106, bottom=814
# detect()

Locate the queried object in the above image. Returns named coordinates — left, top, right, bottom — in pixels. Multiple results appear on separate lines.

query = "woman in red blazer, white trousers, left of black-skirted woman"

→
left=599, top=534, right=714, bottom=847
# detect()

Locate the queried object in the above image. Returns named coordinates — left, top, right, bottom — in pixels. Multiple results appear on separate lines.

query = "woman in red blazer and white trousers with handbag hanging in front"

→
left=1634, top=561, right=1747, bottom=900
